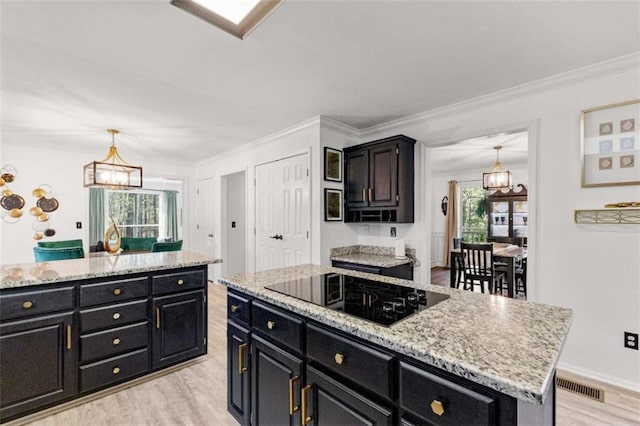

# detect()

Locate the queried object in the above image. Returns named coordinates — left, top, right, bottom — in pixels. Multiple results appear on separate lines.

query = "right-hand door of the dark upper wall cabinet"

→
left=367, top=143, right=398, bottom=207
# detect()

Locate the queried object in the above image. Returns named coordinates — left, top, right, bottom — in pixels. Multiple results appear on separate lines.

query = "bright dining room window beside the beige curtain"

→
left=460, top=186, right=487, bottom=243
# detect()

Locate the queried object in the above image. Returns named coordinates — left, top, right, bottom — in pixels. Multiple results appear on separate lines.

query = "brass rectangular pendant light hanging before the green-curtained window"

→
left=84, top=129, right=142, bottom=189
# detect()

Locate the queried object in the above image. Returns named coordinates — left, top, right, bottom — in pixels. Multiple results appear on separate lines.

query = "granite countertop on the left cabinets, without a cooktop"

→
left=0, top=251, right=222, bottom=290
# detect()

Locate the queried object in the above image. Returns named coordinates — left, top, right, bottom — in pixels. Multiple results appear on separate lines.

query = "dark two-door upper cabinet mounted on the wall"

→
left=344, top=135, right=416, bottom=223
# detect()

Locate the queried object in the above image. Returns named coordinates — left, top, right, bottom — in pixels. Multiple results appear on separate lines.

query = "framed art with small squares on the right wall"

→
left=580, top=99, right=640, bottom=188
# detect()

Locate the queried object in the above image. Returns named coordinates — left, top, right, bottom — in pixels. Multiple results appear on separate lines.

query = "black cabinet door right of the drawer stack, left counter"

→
left=152, top=290, right=207, bottom=369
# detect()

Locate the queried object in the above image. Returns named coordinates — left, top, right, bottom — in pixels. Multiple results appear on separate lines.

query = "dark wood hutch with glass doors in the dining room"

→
left=487, top=184, right=529, bottom=243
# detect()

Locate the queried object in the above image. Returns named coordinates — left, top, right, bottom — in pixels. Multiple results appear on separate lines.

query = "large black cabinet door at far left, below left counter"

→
left=0, top=312, right=77, bottom=420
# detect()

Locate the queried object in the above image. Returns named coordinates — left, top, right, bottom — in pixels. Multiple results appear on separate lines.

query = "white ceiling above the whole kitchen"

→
left=0, top=0, right=640, bottom=165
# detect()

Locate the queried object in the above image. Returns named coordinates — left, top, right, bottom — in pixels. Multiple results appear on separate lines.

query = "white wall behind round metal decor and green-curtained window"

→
left=0, top=142, right=195, bottom=264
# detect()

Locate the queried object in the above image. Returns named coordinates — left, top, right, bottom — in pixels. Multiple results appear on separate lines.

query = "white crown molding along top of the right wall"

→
left=360, top=52, right=640, bottom=137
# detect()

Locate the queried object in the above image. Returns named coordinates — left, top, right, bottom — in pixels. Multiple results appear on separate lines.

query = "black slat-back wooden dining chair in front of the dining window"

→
left=460, top=242, right=505, bottom=293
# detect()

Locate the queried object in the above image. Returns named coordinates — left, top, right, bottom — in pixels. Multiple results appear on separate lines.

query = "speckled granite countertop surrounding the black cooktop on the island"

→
left=219, top=265, right=573, bottom=404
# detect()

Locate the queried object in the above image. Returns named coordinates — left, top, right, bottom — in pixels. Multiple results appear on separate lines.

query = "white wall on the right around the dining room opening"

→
left=356, top=55, right=640, bottom=391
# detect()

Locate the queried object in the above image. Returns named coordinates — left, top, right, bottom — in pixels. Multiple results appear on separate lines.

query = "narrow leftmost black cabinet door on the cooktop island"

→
left=227, top=322, right=251, bottom=426
